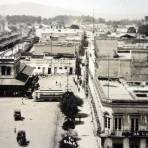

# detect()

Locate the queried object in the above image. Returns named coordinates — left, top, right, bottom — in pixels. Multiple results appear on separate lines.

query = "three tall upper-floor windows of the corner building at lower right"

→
left=104, top=116, right=139, bottom=131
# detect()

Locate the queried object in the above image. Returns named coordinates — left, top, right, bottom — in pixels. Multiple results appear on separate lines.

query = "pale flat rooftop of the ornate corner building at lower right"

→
left=96, top=78, right=148, bottom=105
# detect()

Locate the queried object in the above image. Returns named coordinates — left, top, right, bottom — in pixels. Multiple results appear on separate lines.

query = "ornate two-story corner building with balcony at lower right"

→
left=90, top=77, right=148, bottom=148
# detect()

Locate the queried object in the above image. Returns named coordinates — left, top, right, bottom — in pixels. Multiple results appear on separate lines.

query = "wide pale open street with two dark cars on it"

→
left=0, top=98, right=60, bottom=148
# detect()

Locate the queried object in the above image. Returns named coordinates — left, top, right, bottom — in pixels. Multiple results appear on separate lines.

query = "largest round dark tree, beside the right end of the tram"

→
left=60, top=91, right=83, bottom=120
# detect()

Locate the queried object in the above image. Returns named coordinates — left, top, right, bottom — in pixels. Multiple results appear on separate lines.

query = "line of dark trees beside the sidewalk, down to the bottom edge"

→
left=59, top=91, right=83, bottom=148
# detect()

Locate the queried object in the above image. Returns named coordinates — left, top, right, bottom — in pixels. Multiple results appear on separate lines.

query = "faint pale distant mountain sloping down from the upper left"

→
left=0, top=2, right=84, bottom=17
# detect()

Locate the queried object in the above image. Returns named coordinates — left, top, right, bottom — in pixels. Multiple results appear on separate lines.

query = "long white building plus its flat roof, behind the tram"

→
left=22, top=43, right=76, bottom=75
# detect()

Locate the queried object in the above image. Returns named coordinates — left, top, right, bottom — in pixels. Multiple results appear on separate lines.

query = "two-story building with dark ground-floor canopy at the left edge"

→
left=0, top=55, right=33, bottom=97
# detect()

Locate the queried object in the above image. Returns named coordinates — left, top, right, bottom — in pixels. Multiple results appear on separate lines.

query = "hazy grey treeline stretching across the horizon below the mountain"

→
left=7, top=15, right=142, bottom=26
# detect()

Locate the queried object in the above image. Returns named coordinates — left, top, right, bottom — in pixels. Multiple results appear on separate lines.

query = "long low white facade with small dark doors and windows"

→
left=22, top=55, right=76, bottom=75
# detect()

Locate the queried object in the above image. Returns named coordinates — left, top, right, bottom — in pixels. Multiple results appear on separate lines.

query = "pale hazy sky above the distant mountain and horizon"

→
left=0, top=0, right=148, bottom=18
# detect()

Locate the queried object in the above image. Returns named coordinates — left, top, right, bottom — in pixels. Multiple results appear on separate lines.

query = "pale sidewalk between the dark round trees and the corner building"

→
left=75, top=81, right=99, bottom=148
